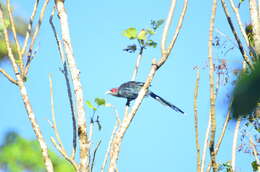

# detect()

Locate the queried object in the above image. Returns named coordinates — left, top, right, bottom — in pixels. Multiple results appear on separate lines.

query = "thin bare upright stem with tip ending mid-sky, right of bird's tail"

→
left=194, top=69, right=200, bottom=172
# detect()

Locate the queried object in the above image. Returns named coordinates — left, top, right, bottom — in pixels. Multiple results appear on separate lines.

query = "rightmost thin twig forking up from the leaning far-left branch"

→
left=24, top=0, right=50, bottom=76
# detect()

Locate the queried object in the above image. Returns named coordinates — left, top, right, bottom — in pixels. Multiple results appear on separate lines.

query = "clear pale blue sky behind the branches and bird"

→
left=0, top=0, right=252, bottom=172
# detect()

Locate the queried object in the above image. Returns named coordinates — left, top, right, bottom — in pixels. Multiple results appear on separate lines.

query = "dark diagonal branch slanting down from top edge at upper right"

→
left=221, top=0, right=252, bottom=69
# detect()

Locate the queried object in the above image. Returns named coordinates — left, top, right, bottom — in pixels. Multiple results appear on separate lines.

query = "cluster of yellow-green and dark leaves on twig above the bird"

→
left=122, top=19, right=164, bottom=53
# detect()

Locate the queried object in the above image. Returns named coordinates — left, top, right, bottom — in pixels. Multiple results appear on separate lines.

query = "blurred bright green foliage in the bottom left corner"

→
left=0, top=132, right=74, bottom=172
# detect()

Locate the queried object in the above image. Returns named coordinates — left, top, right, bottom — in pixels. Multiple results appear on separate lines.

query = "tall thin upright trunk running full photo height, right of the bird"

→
left=208, top=0, right=217, bottom=172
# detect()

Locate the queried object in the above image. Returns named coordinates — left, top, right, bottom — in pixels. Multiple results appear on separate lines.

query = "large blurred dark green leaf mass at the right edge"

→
left=231, top=60, right=260, bottom=119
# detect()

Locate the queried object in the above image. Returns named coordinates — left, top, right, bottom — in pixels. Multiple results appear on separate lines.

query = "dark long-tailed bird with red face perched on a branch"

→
left=106, top=81, right=184, bottom=114
